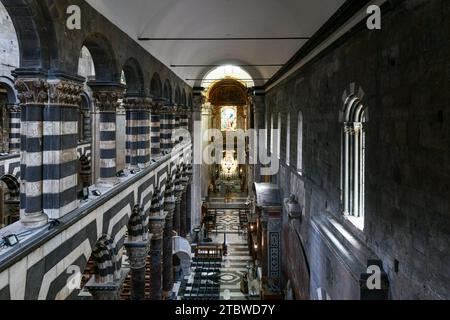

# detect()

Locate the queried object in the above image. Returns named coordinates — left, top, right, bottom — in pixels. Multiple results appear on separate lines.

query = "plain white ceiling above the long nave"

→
left=87, top=0, right=345, bottom=86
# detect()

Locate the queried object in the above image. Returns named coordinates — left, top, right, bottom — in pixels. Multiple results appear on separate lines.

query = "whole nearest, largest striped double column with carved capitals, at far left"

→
left=16, top=78, right=82, bottom=227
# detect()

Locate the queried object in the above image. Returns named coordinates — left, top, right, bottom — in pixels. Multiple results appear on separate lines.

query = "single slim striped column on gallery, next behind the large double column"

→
left=89, top=82, right=124, bottom=187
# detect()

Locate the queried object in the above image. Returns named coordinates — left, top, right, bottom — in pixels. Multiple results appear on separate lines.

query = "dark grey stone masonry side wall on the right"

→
left=266, top=0, right=450, bottom=299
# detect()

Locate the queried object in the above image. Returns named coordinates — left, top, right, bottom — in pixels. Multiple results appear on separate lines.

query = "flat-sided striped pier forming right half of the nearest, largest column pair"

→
left=43, top=80, right=83, bottom=219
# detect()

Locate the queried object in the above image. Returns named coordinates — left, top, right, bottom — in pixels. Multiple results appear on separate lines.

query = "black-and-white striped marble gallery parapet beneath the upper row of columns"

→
left=0, top=144, right=192, bottom=300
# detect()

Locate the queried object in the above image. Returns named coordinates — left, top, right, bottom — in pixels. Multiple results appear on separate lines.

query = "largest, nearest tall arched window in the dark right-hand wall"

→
left=342, top=96, right=368, bottom=230
